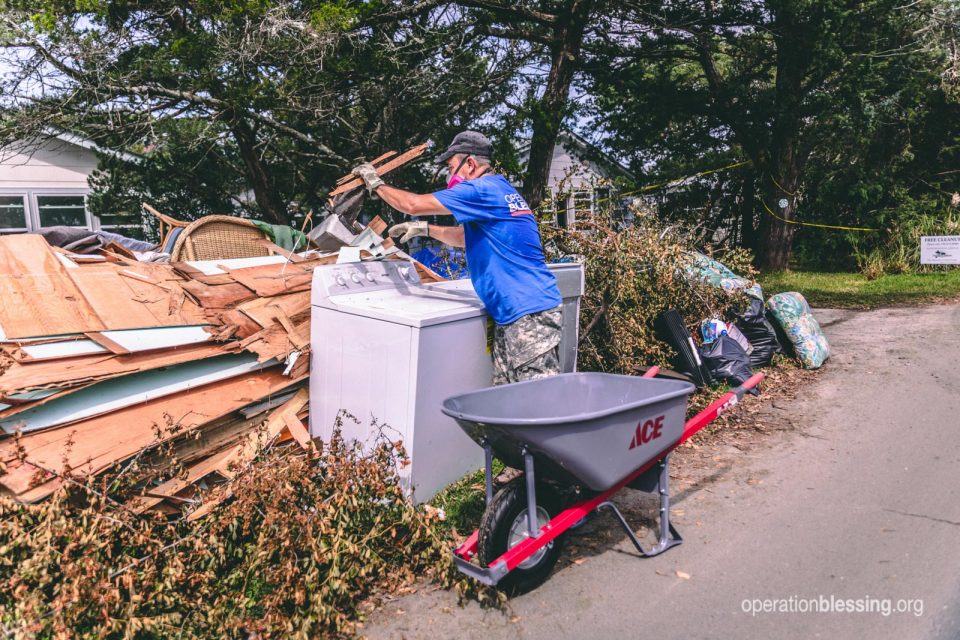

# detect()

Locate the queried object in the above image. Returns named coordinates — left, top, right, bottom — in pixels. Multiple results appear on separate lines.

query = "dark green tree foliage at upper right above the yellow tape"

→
left=589, top=0, right=960, bottom=268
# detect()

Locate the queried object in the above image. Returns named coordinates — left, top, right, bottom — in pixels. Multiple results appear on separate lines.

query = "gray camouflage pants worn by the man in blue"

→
left=493, top=307, right=562, bottom=384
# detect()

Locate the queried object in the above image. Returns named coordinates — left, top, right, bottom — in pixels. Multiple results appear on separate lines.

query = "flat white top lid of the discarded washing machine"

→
left=323, top=287, right=486, bottom=327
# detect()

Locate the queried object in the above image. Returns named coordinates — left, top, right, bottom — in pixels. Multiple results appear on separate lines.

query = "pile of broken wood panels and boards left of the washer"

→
left=0, top=212, right=440, bottom=518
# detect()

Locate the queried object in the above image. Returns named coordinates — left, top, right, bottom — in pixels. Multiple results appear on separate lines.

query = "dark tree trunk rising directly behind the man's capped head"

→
left=523, top=0, right=595, bottom=209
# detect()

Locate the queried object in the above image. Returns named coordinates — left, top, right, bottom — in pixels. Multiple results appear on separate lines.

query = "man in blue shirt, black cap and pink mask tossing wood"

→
left=353, top=131, right=562, bottom=384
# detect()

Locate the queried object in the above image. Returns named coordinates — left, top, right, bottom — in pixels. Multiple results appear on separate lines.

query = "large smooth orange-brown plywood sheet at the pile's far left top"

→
left=0, top=234, right=106, bottom=339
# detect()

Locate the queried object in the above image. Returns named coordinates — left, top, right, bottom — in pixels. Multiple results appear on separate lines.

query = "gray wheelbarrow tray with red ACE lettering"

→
left=443, top=373, right=694, bottom=491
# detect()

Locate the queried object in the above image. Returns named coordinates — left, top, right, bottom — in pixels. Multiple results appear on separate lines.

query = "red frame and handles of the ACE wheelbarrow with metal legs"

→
left=453, top=367, right=764, bottom=586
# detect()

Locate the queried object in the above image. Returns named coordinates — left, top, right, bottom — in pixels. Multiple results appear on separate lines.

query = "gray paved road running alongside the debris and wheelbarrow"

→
left=364, top=306, right=960, bottom=640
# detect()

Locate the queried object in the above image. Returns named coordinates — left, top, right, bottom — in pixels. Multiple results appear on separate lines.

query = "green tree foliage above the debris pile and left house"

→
left=0, top=0, right=523, bottom=223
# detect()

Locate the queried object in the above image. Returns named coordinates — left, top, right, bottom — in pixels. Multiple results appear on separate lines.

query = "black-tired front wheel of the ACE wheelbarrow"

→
left=477, top=476, right=564, bottom=594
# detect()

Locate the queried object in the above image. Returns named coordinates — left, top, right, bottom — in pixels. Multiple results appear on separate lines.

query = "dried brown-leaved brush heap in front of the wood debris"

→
left=0, top=428, right=457, bottom=638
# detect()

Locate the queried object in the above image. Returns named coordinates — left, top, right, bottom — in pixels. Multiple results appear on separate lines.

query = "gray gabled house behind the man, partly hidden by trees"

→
left=519, top=131, right=636, bottom=227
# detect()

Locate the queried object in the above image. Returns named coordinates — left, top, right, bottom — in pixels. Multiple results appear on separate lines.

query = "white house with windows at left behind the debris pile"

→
left=0, top=130, right=142, bottom=235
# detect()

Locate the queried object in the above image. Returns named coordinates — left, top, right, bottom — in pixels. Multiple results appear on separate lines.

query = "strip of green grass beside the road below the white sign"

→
left=759, top=269, right=960, bottom=308
